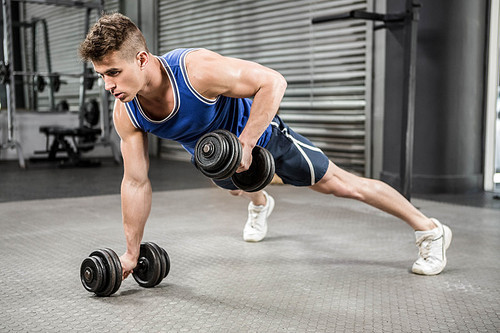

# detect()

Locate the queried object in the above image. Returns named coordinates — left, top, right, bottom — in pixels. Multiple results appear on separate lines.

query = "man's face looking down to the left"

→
left=93, top=52, right=141, bottom=103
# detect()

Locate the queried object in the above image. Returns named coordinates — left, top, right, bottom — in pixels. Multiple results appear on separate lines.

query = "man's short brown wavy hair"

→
left=78, top=13, right=149, bottom=61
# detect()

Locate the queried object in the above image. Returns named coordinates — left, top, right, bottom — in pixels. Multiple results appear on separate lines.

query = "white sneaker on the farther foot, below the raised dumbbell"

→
left=243, top=191, right=274, bottom=242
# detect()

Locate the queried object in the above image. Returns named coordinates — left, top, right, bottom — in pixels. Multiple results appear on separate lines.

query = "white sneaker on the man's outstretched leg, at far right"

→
left=411, top=219, right=452, bottom=275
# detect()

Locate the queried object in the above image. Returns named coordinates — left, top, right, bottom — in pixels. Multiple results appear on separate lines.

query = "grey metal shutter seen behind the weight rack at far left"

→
left=22, top=0, right=119, bottom=112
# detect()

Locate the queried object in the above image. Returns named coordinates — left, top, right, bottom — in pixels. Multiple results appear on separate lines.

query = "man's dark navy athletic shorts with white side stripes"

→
left=213, top=116, right=329, bottom=190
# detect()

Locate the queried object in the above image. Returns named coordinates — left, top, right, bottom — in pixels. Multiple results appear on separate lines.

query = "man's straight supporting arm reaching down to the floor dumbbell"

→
left=113, top=101, right=152, bottom=279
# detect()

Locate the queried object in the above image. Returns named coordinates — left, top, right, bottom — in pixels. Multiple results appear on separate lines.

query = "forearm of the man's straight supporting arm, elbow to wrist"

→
left=121, top=179, right=152, bottom=258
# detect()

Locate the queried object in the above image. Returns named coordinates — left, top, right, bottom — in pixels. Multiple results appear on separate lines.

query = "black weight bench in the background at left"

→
left=32, top=126, right=101, bottom=166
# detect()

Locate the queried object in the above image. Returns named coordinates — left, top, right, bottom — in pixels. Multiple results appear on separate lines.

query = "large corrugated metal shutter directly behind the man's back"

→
left=159, top=0, right=371, bottom=174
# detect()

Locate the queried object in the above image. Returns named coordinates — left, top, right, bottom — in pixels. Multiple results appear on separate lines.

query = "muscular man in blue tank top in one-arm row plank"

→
left=80, top=14, right=452, bottom=278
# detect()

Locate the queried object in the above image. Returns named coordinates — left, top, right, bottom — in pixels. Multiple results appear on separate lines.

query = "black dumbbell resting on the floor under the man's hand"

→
left=80, top=242, right=170, bottom=297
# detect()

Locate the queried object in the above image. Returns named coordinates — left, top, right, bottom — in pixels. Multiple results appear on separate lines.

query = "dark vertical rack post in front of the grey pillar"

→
left=400, top=0, right=420, bottom=200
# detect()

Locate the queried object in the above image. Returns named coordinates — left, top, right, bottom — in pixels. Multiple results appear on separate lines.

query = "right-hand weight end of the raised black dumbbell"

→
left=231, top=146, right=275, bottom=192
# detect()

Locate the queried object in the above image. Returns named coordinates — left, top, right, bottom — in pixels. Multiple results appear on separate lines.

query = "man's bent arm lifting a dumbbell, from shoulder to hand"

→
left=186, top=50, right=287, bottom=172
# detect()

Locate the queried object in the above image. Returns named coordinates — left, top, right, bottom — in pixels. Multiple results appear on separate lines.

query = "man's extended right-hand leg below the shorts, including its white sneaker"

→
left=311, top=162, right=452, bottom=275
